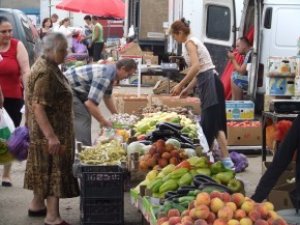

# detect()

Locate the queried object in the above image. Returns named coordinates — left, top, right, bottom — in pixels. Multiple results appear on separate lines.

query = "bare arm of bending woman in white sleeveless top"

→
left=171, top=41, right=201, bottom=95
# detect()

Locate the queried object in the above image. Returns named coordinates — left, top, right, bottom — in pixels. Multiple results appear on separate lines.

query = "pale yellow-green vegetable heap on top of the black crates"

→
left=79, top=140, right=126, bottom=165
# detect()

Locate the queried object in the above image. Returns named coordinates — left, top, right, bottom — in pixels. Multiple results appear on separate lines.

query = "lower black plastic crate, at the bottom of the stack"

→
left=80, top=198, right=124, bottom=225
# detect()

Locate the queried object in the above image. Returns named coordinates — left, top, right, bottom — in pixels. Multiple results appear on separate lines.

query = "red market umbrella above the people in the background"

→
left=56, top=0, right=125, bottom=20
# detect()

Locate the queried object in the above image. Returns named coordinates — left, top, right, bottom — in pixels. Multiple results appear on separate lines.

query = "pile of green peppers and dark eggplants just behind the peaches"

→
left=135, top=156, right=244, bottom=198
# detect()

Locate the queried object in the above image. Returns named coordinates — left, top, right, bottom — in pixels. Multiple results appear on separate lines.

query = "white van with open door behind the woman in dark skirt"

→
left=169, top=0, right=300, bottom=111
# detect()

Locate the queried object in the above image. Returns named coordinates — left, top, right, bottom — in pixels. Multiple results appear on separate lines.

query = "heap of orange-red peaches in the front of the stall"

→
left=157, top=192, right=287, bottom=225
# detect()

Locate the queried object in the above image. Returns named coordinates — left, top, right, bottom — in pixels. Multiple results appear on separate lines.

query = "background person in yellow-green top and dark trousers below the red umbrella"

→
left=89, top=16, right=104, bottom=62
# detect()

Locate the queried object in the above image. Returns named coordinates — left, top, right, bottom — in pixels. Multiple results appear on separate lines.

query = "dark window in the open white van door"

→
left=206, top=5, right=231, bottom=41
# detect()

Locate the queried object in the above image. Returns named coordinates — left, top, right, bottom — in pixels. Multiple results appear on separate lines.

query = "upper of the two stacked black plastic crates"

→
left=80, top=166, right=124, bottom=199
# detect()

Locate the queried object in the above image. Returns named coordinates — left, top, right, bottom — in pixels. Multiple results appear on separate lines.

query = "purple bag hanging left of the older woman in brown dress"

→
left=7, top=126, right=29, bottom=161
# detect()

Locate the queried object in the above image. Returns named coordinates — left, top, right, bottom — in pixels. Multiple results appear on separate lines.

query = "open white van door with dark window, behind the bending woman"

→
left=201, top=0, right=237, bottom=74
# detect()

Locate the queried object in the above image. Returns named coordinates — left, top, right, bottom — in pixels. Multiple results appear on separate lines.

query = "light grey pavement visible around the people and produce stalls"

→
left=0, top=88, right=268, bottom=225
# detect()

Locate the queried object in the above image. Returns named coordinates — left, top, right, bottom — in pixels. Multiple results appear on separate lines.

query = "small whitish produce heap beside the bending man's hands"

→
left=110, top=113, right=139, bottom=129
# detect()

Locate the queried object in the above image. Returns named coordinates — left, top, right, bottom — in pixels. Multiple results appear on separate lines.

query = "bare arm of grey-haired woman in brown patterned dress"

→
left=33, top=103, right=61, bottom=154
